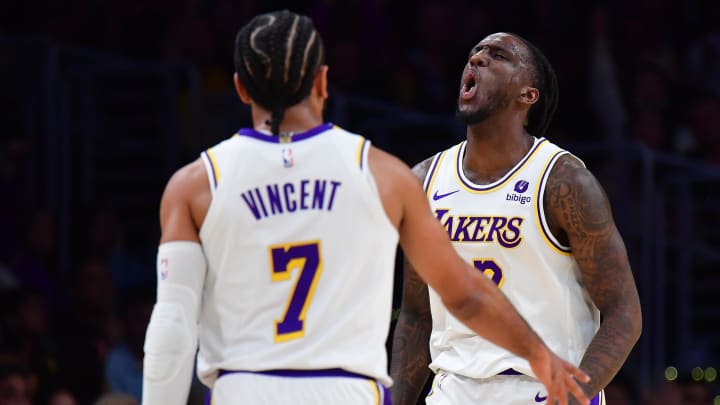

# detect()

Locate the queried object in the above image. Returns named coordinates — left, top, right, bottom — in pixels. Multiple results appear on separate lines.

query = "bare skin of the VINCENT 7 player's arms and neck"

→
left=160, top=32, right=588, bottom=404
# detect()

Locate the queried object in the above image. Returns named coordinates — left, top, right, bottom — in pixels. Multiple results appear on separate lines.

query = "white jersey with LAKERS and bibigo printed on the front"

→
left=424, top=138, right=600, bottom=378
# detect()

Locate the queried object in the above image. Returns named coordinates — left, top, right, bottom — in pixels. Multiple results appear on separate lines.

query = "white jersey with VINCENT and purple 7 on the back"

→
left=198, top=123, right=398, bottom=386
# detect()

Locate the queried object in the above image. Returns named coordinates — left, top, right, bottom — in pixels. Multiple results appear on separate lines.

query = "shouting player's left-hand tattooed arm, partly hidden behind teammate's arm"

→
left=390, top=158, right=432, bottom=405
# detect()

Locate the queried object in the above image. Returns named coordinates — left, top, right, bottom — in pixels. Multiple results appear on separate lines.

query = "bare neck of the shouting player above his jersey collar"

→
left=463, top=123, right=534, bottom=184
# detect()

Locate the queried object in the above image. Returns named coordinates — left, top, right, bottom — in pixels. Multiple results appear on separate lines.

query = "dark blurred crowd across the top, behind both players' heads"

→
left=0, top=0, right=720, bottom=159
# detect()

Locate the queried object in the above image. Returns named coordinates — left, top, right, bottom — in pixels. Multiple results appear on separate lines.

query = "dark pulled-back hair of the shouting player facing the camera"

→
left=510, top=33, right=560, bottom=137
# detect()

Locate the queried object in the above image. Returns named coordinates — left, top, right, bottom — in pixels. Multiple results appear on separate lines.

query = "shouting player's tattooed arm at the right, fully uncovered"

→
left=544, top=155, right=642, bottom=396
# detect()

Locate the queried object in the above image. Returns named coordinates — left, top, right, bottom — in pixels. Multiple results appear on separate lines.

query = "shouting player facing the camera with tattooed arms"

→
left=391, top=33, right=641, bottom=405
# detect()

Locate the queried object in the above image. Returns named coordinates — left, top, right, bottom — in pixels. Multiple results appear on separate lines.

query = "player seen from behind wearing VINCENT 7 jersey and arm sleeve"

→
left=143, top=11, right=588, bottom=405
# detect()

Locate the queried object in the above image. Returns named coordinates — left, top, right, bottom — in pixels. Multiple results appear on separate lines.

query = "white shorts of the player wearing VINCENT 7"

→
left=211, top=370, right=391, bottom=405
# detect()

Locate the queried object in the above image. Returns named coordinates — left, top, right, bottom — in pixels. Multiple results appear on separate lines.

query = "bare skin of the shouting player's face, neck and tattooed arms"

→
left=390, top=33, right=642, bottom=405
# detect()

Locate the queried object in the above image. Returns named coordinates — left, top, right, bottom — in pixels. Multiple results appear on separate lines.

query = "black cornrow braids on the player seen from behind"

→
left=235, top=10, right=325, bottom=135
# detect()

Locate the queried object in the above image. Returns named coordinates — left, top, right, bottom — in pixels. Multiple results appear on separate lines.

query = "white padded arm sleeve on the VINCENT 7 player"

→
left=142, top=241, right=207, bottom=405
